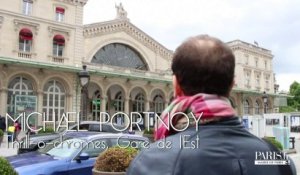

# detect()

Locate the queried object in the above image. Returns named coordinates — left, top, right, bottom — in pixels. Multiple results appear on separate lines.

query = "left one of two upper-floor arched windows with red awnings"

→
left=19, top=28, right=33, bottom=52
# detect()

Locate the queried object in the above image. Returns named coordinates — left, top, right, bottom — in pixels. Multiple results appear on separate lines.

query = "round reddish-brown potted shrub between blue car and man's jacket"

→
left=94, top=147, right=138, bottom=172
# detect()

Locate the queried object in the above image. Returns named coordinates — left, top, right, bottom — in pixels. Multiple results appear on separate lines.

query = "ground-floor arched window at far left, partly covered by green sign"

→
left=7, top=76, right=33, bottom=114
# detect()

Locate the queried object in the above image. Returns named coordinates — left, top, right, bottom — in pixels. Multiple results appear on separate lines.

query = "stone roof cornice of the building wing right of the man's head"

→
left=227, top=40, right=273, bottom=59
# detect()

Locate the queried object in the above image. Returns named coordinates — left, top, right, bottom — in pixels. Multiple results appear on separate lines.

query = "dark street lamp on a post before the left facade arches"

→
left=78, top=65, right=90, bottom=120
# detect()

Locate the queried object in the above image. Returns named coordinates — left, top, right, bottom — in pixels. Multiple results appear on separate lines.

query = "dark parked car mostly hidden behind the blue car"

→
left=18, top=121, right=133, bottom=154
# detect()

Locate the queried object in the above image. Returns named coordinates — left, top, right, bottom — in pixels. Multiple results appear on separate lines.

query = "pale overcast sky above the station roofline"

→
left=84, top=0, right=300, bottom=90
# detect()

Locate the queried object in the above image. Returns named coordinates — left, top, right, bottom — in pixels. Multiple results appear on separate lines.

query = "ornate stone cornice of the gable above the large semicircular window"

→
left=83, top=20, right=173, bottom=60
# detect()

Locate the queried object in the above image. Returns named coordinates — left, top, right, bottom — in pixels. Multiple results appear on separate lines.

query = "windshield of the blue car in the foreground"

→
left=38, top=138, right=85, bottom=158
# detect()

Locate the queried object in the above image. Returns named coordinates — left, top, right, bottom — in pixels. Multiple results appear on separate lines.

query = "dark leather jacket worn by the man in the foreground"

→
left=127, top=117, right=296, bottom=175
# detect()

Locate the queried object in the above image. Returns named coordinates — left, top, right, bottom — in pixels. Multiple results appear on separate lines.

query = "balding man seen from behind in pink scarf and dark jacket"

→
left=127, top=35, right=296, bottom=175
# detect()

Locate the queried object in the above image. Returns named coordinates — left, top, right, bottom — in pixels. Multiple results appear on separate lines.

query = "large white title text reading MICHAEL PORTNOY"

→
left=5, top=112, right=203, bottom=132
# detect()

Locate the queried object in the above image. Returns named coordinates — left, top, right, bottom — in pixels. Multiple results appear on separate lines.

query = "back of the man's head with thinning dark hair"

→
left=172, top=35, right=235, bottom=96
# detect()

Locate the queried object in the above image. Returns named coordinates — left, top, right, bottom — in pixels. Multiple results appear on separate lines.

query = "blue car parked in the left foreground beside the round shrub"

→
left=7, top=132, right=149, bottom=175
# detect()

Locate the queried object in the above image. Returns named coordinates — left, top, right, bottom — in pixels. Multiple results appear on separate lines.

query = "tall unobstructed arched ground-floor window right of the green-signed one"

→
left=43, top=80, right=66, bottom=121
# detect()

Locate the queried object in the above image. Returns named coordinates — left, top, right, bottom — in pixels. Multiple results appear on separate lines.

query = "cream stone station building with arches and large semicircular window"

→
left=0, top=0, right=286, bottom=125
